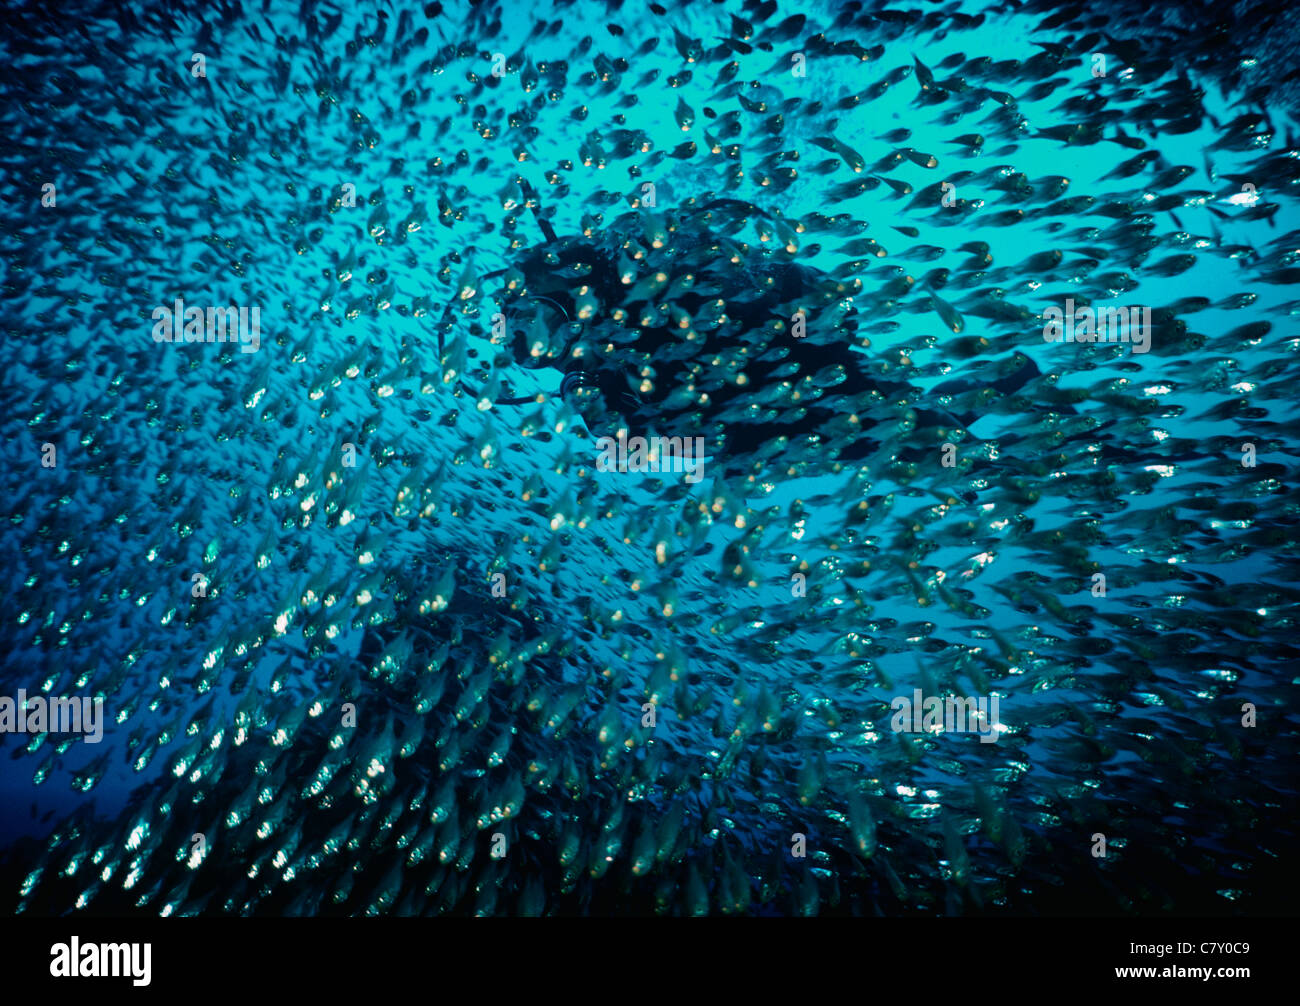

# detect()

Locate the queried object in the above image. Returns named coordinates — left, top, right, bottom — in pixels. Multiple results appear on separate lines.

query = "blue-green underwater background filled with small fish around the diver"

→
left=0, top=0, right=1300, bottom=915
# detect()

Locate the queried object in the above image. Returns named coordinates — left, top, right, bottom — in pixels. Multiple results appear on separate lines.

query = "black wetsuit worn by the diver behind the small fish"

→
left=491, top=205, right=1037, bottom=475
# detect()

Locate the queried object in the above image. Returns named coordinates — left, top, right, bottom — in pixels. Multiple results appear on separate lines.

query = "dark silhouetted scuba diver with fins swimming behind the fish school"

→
left=431, top=183, right=1039, bottom=474
